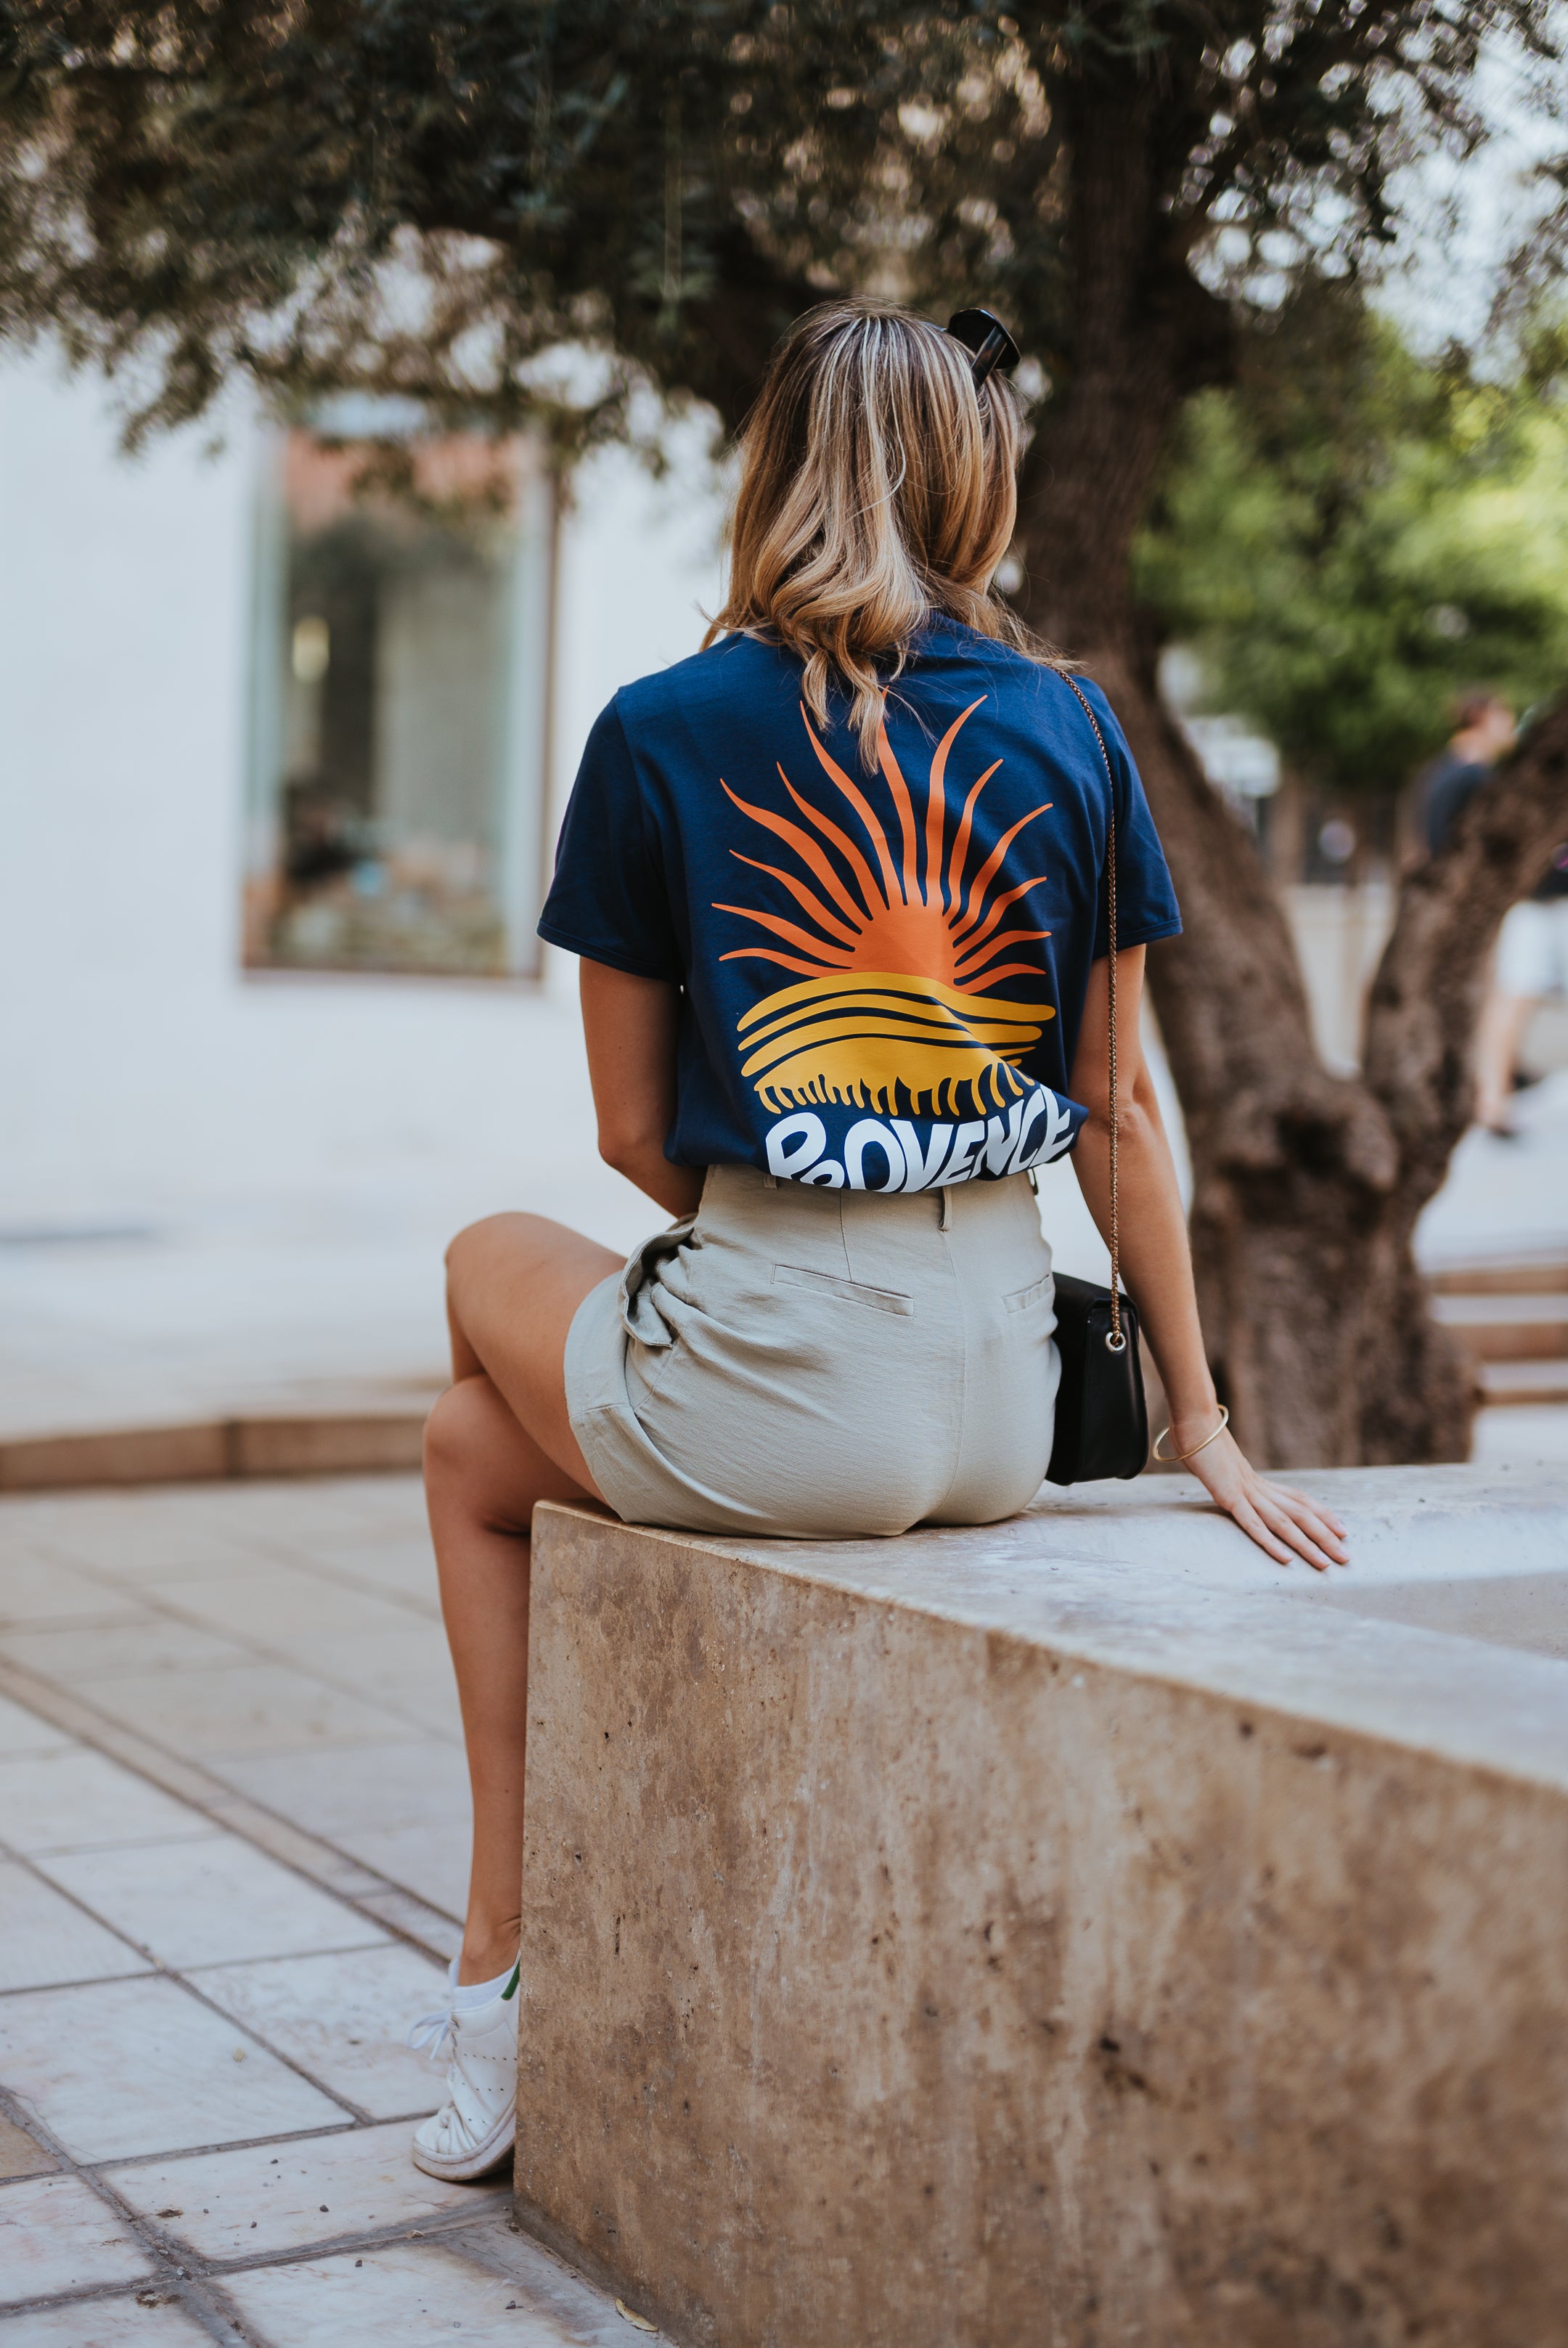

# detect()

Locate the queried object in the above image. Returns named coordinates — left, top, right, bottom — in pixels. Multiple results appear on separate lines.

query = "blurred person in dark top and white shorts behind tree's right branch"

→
left=1418, top=688, right=1568, bottom=1141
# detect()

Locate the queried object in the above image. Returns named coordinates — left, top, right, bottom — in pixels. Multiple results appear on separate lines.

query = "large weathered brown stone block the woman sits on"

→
left=516, top=1467, right=1568, bottom=2348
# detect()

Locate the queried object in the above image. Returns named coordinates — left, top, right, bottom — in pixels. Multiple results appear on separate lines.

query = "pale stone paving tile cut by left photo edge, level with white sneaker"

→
left=0, top=1977, right=348, bottom=2160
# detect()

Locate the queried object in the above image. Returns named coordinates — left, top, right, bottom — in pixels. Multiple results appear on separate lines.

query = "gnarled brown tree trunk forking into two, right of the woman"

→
left=1018, top=78, right=1568, bottom=1467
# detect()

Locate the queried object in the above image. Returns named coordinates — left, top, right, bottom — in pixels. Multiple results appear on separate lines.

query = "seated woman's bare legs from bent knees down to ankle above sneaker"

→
left=425, top=1214, right=620, bottom=1981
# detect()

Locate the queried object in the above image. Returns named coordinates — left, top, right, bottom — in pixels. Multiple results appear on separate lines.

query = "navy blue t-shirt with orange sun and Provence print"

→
left=540, top=620, right=1180, bottom=1191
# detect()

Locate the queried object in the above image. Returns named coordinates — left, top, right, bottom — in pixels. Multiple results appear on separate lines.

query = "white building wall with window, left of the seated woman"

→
left=0, top=359, right=721, bottom=1228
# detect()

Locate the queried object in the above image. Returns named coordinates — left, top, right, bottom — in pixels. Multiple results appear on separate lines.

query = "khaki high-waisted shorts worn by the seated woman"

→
left=565, top=1167, right=1061, bottom=1536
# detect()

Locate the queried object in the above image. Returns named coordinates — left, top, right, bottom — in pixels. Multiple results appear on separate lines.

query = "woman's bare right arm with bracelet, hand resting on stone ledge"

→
left=1070, top=946, right=1347, bottom=1571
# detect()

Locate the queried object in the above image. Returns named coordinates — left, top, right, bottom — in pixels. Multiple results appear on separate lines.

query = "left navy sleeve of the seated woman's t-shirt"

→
left=540, top=702, right=683, bottom=984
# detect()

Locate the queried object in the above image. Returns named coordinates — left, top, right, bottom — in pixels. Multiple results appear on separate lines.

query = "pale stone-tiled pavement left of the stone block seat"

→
left=0, top=1477, right=634, bottom=2348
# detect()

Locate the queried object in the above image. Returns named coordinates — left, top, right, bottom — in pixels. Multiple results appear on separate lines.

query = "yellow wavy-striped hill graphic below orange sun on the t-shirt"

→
left=737, top=970, right=1054, bottom=1115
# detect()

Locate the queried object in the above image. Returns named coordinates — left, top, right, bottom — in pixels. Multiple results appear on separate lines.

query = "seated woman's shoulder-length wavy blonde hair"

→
left=702, top=301, right=1056, bottom=768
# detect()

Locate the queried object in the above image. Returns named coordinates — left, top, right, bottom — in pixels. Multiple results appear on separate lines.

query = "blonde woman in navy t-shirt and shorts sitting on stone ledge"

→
left=413, top=303, right=1345, bottom=2177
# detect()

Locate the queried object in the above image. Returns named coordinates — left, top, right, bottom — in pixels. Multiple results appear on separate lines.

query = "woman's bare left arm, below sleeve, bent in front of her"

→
left=580, top=963, right=702, bottom=1216
